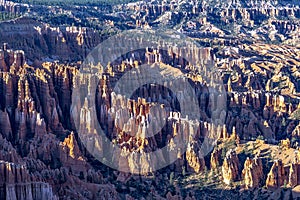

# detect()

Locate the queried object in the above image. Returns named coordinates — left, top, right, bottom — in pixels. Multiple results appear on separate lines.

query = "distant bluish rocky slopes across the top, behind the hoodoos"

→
left=0, top=0, right=300, bottom=61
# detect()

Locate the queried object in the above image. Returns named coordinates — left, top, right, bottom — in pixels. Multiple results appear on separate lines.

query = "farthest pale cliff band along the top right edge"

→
left=128, top=1, right=300, bottom=24
